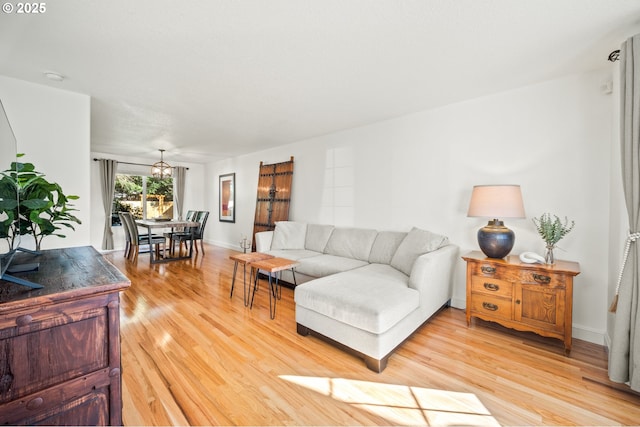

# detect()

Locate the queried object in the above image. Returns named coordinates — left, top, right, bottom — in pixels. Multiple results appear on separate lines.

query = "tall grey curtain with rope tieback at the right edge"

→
left=609, top=34, right=640, bottom=391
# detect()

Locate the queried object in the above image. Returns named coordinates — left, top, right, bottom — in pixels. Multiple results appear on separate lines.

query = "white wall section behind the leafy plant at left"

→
left=0, top=76, right=91, bottom=249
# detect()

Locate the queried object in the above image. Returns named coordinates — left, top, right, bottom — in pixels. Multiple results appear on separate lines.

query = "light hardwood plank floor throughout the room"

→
left=106, top=245, right=640, bottom=425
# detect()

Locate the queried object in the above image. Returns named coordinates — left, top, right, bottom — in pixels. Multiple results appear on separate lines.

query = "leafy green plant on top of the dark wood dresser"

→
left=0, top=154, right=82, bottom=251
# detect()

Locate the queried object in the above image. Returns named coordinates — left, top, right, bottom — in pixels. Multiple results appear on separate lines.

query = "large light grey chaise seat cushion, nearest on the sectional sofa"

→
left=295, top=264, right=420, bottom=334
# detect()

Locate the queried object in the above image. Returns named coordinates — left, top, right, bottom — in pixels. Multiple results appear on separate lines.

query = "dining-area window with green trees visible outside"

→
left=111, top=174, right=173, bottom=225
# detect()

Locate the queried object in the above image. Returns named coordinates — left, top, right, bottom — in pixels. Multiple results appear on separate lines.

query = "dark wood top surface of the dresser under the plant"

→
left=0, top=246, right=131, bottom=313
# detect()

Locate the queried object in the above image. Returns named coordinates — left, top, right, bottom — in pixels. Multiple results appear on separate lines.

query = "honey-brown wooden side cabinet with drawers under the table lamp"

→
left=462, top=252, right=580, bottom=355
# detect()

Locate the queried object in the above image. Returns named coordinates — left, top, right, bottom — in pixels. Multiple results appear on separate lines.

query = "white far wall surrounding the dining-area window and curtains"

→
left=90, top=152, right=206, bottom=250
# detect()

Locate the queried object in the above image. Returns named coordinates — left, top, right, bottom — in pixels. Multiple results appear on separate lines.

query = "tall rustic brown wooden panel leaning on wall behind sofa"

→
left=252, top=156, right=293, bottom=250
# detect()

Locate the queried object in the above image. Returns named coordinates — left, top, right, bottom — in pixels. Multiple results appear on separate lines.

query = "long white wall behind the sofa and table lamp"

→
left=206, top=69, right=613, bottom=344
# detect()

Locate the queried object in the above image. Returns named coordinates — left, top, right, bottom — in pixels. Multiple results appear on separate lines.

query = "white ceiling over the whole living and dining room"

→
left=0, top=0, right=640, bottom=162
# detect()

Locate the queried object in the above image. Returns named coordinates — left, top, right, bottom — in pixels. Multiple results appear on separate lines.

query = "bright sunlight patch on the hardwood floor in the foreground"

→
left=280, top=375, right=500, bottom=426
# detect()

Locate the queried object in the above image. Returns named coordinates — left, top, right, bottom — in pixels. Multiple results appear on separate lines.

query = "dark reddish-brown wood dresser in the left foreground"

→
left=0, top=246, right=130, bottom=425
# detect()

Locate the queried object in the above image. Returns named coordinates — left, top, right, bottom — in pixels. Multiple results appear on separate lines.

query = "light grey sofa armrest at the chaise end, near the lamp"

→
left=409, top=244, right=459, bottom=306
